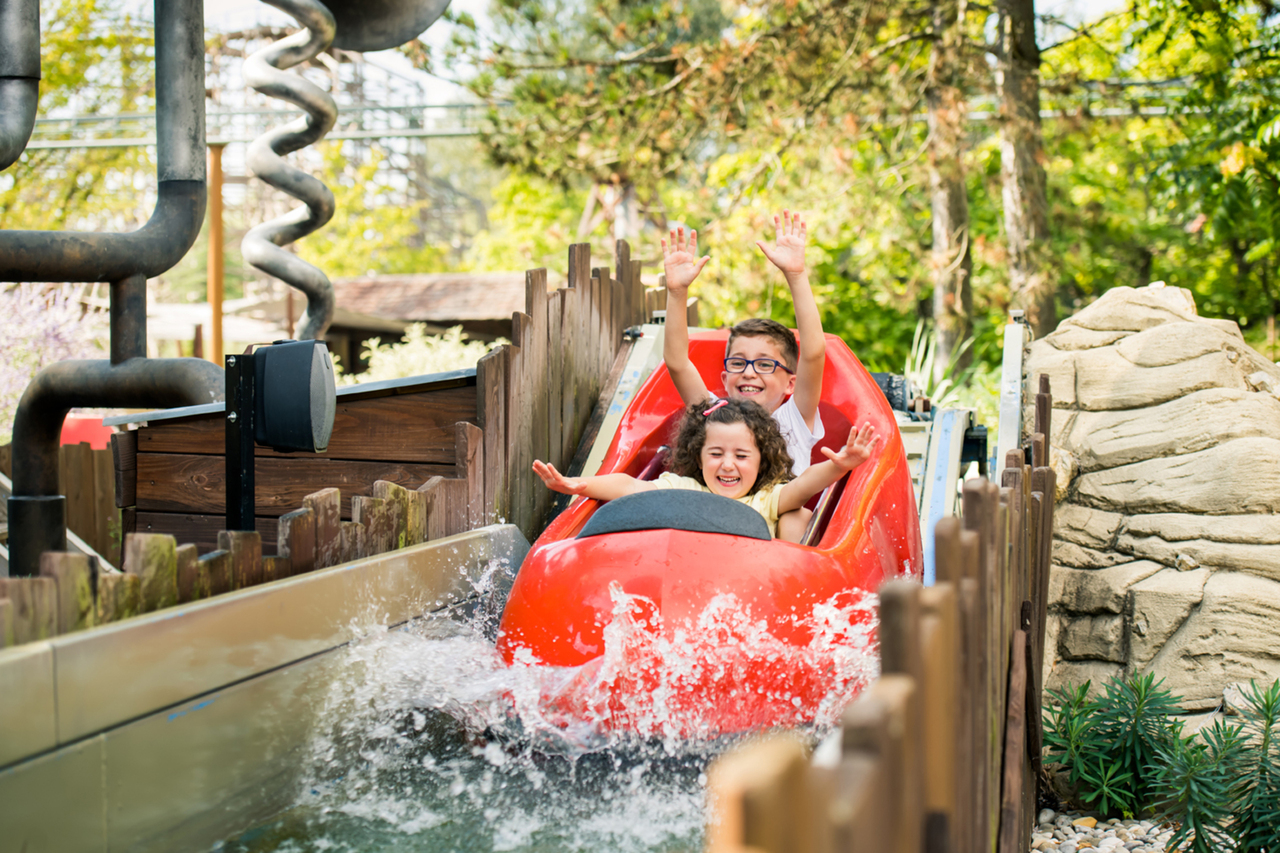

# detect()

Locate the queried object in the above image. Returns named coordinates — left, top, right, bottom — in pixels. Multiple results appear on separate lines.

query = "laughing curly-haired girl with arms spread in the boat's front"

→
left=534, top=400, right=879, bottom=537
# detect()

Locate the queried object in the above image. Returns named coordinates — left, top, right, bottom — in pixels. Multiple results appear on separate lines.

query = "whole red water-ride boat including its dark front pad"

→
left=498, top=330, right=922, bottom=735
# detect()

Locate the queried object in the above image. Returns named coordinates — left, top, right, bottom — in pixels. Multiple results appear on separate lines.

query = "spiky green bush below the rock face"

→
left=1044, top=675, right=1280, bottom=853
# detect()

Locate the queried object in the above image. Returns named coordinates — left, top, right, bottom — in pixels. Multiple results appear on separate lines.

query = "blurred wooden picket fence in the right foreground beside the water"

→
left=708, top=377, right=1055, bottom=853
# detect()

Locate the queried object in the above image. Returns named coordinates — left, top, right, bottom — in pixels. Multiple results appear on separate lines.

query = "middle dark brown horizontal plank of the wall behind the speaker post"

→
left=137, top=453, right=453, bottom=519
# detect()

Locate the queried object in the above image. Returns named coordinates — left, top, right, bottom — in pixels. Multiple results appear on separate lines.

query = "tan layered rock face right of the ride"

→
left=1028, top=286, right=1280, bottom=710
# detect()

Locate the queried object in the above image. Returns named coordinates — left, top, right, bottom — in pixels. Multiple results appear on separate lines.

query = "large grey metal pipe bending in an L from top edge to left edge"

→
left=0, top=0, right=206, bottom=282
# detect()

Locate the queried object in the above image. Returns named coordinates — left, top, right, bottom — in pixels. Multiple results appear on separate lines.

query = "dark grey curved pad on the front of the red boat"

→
left=577, top=489, right=772, bottom=540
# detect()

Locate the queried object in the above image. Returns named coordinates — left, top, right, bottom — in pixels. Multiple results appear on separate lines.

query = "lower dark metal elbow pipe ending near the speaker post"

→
left=9, top=359, right=224, bottom=576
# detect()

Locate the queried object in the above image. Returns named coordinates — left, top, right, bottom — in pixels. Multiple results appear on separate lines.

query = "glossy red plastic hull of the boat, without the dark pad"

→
left=498, top=332, right=922, bottom=731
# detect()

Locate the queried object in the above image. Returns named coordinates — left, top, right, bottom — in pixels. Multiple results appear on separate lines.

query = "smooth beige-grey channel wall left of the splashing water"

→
left=0, top=525, right=529, bottom=853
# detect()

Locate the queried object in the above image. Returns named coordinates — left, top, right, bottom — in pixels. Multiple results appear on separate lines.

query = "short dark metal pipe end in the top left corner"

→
left=0, top=0, right=40, bottom=172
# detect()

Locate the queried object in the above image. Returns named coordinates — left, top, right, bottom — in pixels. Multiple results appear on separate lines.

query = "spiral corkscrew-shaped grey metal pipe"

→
left=241, top=0, right=338, bottom=341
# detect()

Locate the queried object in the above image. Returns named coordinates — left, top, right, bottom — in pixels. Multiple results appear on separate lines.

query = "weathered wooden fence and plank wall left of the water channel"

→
left=0, top=241, right=659, bottom=647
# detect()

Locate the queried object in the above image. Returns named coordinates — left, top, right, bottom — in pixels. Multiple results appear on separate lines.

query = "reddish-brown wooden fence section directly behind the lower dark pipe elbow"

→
left=0, top=442, right=123, bottom=566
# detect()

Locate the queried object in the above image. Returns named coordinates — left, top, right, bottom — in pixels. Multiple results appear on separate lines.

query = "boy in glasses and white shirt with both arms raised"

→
left=662, top=210, right=827, bottom=542
